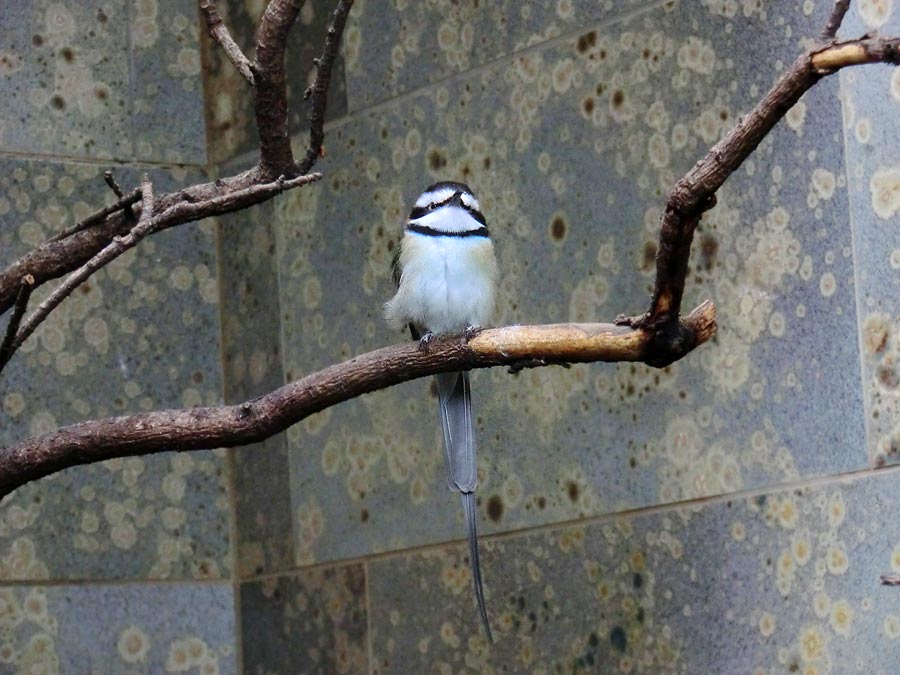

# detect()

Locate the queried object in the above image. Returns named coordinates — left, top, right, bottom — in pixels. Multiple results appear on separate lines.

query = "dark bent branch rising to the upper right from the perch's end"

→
left=618, top=32, right=898, bottom=326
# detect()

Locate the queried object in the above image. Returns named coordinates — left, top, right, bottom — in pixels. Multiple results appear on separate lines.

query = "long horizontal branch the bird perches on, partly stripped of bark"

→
left=0, top=303, right=715, bottom=498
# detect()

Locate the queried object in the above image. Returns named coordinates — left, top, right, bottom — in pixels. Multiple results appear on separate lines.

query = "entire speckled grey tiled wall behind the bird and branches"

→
left=0, top=0, right=900, bottom=674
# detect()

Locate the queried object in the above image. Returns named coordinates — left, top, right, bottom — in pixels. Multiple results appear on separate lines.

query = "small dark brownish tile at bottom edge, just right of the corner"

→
left=241, top=565, right=369, bottom=675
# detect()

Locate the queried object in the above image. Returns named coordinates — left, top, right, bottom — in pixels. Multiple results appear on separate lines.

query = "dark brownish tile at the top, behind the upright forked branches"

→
left=203, top=0, right=347, bottom=162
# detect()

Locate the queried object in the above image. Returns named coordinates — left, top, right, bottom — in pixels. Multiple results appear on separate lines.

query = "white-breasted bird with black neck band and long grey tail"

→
left=384, top=181, right=499, bottom=642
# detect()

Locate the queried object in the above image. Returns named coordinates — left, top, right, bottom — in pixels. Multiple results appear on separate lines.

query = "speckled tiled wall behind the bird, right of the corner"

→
left=239, top=0, right=900, bottom=673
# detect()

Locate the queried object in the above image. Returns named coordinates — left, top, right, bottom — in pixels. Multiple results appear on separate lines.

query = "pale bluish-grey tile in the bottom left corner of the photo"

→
left=0, top=584, right=238, bottom=675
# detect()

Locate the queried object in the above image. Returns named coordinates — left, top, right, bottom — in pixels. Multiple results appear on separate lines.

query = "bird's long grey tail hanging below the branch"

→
left=434, top=372, right=494, bottom=642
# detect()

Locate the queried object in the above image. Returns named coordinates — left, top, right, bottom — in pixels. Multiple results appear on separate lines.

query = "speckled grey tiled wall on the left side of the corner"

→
left=0, top=0, right=238, bottom=675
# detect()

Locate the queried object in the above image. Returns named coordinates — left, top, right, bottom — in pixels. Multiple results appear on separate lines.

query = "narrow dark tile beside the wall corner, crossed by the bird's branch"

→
left=219, top=202, right=294, bottom=576
